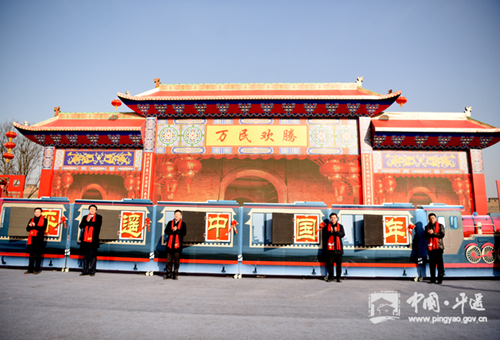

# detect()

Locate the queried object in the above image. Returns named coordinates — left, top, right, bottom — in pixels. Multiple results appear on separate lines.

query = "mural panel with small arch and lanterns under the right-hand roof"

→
left=373, top=151, right=473, bottom=214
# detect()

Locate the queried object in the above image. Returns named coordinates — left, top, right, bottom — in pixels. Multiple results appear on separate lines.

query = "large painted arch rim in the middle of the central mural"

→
left=219, top=168, right=288, bottom=203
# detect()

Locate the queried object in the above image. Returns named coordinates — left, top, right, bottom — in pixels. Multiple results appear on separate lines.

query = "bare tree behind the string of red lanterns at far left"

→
left=0, top=120, right=43, bottom=198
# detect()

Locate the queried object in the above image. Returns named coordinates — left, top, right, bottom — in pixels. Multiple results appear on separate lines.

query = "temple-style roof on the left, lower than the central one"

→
left=13, top=112, right=145, bottom=148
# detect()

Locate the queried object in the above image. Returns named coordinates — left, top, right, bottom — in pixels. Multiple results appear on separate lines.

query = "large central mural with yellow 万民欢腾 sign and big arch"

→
left=153, top=118, right=361, bottom=204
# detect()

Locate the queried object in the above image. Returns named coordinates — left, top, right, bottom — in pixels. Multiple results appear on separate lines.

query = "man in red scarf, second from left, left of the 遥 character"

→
left=79, top=204, right=102, bottom=276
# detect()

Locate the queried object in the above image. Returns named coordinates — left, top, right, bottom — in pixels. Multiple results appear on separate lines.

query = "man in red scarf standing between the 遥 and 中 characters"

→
left=164, top=210, right=186, bottom=280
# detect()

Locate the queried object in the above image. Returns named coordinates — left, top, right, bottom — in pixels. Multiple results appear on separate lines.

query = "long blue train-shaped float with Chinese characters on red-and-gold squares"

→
left=0, top=198, right=500, bottom=278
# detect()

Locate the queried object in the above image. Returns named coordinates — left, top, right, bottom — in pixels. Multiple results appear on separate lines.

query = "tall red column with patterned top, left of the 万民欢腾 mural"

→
left=139, top=117, right=157, bottom=201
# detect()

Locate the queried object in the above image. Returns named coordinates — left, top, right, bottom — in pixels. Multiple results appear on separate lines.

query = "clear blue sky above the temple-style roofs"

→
left=0, top=0, right=500, bottom=197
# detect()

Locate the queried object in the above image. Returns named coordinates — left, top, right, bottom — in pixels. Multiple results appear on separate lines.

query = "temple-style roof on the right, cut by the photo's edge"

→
left=372, top=112, right=500, bottom=149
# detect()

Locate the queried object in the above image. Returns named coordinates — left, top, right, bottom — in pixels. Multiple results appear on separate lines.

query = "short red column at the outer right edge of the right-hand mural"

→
left=469, top=149, right=488, bottom=215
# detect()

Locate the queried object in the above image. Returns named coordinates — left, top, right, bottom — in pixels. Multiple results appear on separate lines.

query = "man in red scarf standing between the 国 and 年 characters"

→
left=323, top=213, right=345, bottom=282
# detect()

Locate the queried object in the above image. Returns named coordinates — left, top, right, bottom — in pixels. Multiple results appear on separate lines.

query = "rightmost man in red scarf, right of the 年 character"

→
left=424, top=213, right=444, bottom=284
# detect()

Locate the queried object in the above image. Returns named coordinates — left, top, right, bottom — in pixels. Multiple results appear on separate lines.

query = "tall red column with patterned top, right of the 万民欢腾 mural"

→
left=358, top=117, right=375, bottom=205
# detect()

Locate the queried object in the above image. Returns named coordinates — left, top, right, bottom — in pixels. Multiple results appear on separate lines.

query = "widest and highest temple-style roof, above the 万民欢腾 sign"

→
left=117, top=82, right=401, bottom=118
